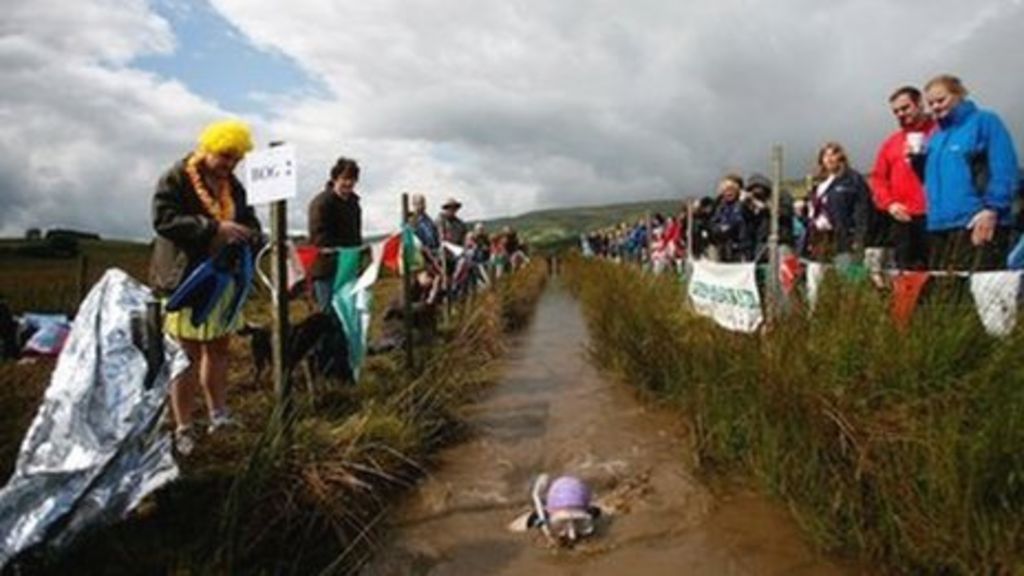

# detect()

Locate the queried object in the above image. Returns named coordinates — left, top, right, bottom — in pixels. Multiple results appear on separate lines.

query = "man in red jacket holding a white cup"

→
left=871, top=86, right=935, bottom=270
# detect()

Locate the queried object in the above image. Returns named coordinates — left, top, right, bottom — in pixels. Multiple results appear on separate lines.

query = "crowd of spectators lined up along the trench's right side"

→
left=585, top=75, right=1022, bottom=279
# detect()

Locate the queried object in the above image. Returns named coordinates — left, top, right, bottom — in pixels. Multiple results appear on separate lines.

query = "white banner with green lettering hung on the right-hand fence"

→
left=687, top=260, right=764, bottom=332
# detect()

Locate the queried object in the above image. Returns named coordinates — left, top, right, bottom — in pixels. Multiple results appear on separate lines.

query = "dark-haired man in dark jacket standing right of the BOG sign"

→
left=308, top=156, right=362, bottom=380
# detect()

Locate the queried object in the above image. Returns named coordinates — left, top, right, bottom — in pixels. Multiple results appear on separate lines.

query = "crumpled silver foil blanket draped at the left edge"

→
left=0, top=270, right=188, bottom=568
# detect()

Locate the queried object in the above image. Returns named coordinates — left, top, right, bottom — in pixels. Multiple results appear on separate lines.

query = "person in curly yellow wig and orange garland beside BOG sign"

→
left=150, top=120, right=260, bottom=454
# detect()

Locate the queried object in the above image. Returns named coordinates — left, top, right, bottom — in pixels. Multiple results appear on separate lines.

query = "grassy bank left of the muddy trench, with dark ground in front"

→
left=0, top=265, right=546, bottom=574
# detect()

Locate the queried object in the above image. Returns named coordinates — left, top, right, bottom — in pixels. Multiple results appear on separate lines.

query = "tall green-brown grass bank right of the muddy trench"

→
left=567, top=261, right=1024, bottom=574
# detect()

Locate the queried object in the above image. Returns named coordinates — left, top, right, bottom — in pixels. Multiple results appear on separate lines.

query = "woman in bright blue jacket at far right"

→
left=925, top=75, right=1018, bottom=271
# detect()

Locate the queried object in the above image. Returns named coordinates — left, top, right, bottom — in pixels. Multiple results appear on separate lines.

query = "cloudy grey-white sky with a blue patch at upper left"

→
left=0, top=0, right=1024, bottom=239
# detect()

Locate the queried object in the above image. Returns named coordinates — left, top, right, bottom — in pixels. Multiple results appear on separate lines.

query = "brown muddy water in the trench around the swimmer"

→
left=362, top=283, right=853, bottom=576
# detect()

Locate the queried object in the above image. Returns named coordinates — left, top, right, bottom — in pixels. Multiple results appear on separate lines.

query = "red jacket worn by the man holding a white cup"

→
left=871, top=119, right=936, bottom=216
